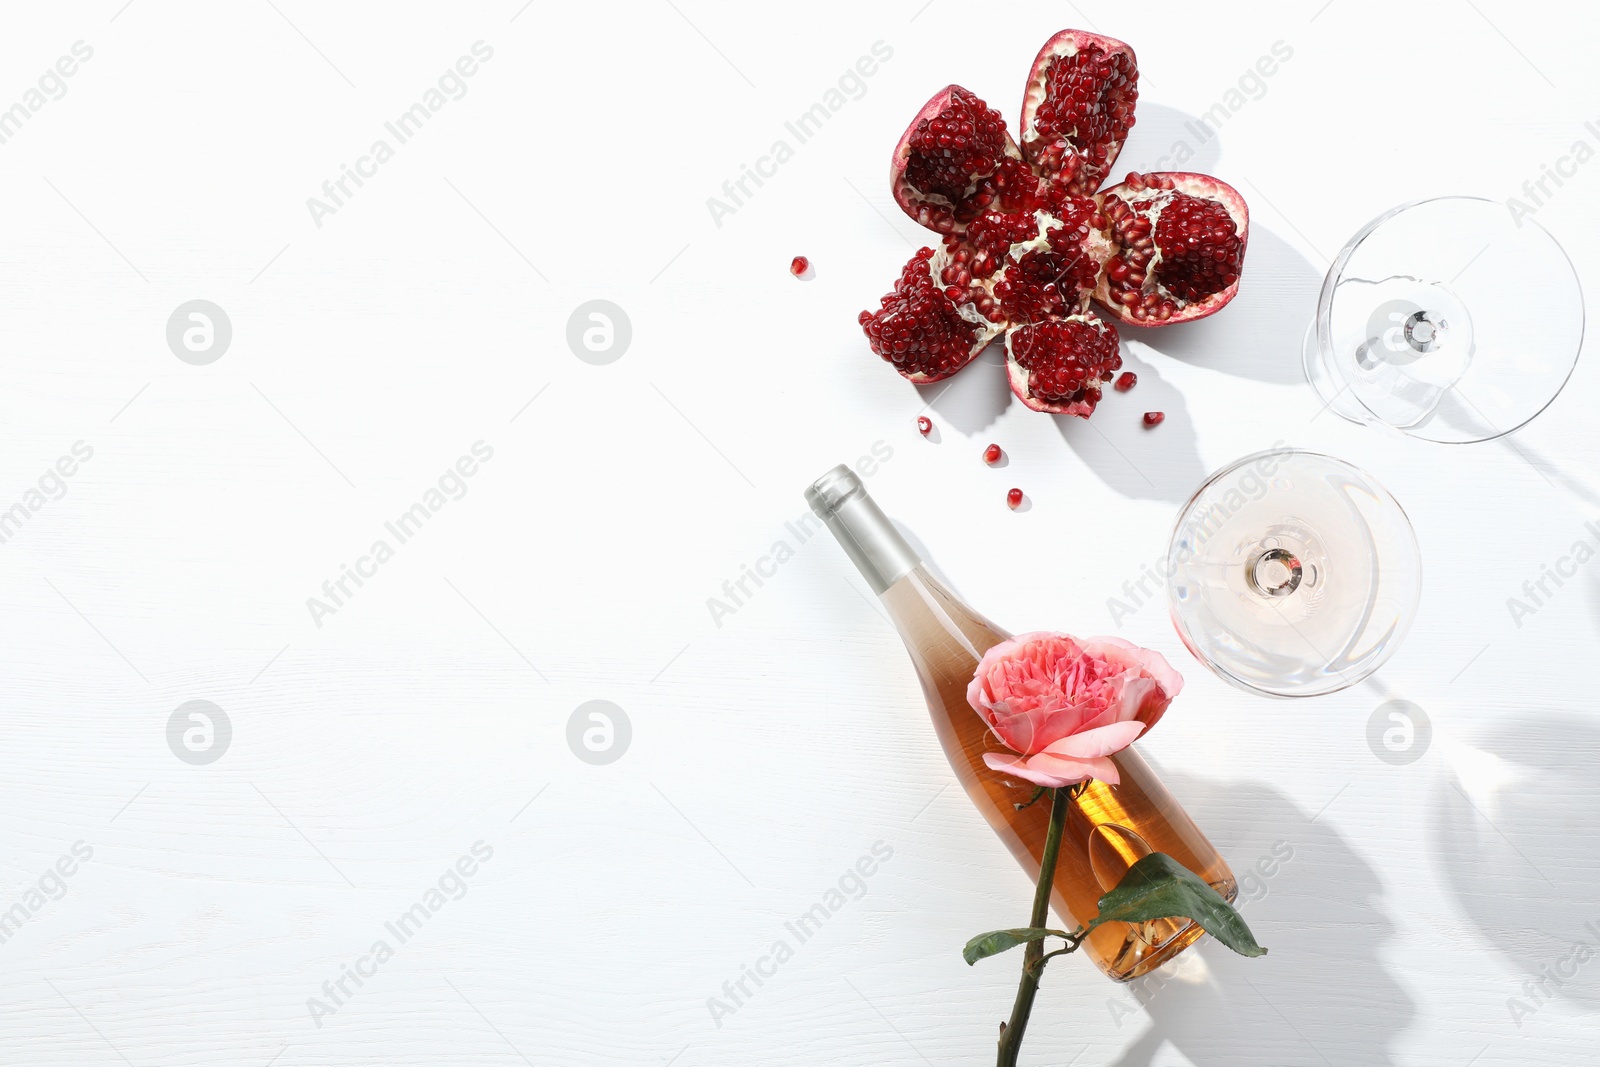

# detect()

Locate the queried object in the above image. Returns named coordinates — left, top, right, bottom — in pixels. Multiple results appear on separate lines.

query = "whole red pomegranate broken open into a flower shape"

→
left=858, top=30, right=1250, bottom=418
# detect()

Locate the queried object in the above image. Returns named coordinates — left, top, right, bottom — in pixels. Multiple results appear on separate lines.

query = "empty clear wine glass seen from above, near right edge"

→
left=1302, top=197, right=1584, bottom=445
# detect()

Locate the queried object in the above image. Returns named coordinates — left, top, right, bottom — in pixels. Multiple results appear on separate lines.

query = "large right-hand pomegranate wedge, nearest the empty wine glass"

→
left=1094, top=171, right=1250, bottom=326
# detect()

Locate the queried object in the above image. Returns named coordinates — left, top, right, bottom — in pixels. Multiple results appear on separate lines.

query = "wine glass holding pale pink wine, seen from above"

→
left=1166, top=448, right=1422, bottom=696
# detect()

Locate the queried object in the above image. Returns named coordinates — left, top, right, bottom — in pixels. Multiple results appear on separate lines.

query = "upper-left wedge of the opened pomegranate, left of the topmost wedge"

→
left=890, top=85, right=1038, bottom=234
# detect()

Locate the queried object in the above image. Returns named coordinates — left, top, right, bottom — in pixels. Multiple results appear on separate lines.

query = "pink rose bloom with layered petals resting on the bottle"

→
left=966, top=633, right=1184, bottom=789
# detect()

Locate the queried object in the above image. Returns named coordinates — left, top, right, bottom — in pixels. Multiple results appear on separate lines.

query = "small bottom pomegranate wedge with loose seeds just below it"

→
left=1005, top=314, right=1122, bottom=419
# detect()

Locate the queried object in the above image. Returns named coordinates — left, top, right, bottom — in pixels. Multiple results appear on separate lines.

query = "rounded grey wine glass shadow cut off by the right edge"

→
left=1434, top=712, right=1600, bottom=1027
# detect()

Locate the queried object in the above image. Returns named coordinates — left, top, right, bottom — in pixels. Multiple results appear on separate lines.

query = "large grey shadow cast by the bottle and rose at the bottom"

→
left=1106, top=774, right=1416, bottom=1067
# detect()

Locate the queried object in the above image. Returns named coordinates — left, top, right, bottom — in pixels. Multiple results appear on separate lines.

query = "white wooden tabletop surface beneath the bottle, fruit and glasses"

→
left=0, top=0, right=1600, bottom=1067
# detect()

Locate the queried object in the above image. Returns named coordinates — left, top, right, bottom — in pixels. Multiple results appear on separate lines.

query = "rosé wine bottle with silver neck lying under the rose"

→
left=806, top=466, right=1238, bottom=982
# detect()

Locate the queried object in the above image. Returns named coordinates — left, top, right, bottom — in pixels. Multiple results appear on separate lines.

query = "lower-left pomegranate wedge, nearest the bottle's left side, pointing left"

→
left=856, top=248, right=1000, bottom=382
